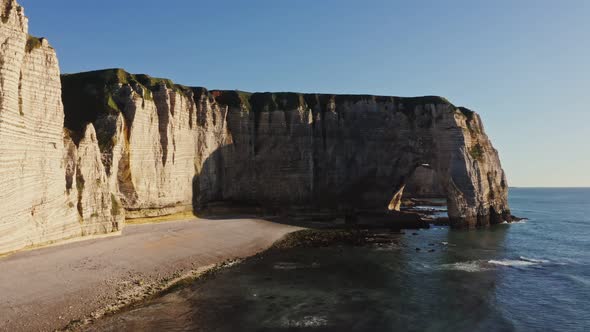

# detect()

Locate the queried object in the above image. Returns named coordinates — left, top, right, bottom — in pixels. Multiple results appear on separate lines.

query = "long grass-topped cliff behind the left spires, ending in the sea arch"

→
left=62, top=69, right=510, bottom=227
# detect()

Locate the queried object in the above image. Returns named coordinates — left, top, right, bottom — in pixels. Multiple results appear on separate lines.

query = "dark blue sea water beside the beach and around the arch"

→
left=91, top=188, right=590, bottom=331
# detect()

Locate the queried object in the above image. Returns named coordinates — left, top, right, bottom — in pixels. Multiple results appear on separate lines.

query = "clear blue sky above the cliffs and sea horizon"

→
left=19, top=0, right=590, bottom=186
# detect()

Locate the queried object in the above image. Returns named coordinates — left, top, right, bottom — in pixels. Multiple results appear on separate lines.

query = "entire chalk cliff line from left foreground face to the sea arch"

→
left=0, top=0, right=510, bottom=253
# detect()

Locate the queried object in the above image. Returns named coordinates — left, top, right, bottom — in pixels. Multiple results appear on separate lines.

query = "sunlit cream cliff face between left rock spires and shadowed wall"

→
left=110, top=85, right=231, bottom=218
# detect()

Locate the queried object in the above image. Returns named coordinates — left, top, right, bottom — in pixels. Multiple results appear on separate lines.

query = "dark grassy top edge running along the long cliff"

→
left=62, top=68, right=473, bottom=130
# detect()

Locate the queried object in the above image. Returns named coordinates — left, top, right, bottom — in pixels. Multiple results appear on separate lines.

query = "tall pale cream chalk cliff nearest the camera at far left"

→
left=0, top=0, right=121, bottom=253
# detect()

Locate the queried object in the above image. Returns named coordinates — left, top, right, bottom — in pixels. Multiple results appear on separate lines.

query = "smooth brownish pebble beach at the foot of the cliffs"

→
left=0, top=218, right=300, bottom=331
